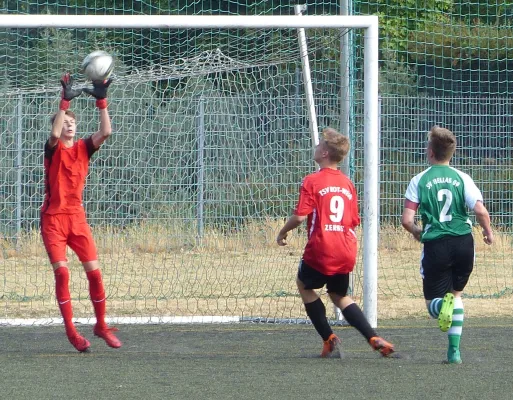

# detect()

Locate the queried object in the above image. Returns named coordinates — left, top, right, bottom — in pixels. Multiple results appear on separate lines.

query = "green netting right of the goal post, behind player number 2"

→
left=352, top=1, right=513, bottom=316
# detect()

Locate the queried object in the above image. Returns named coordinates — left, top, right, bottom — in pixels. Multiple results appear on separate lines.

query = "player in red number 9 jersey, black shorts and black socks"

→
left=276, top=128, right=394, bottom=357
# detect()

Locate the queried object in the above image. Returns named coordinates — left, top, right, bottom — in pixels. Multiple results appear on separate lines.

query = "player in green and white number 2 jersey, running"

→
left=401, top=126, right=493, bottom=364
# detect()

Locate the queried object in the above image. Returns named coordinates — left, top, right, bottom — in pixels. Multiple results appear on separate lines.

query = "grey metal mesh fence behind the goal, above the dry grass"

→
left=0, top=94, right=513, bottom=237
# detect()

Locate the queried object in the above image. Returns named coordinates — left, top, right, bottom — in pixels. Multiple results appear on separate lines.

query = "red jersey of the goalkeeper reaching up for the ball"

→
left=41, top=137, right=97, bottom=214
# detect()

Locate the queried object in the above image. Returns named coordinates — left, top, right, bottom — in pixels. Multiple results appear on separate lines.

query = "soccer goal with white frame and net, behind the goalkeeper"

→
left=0, top=15, right=378, bottom=325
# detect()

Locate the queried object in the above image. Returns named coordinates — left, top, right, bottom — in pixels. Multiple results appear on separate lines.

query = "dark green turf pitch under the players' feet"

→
left=0, top=318, right=513, bottom=400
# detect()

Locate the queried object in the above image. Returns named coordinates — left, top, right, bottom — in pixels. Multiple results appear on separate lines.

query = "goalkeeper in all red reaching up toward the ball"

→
left=41, top=74, right=121, bottom=352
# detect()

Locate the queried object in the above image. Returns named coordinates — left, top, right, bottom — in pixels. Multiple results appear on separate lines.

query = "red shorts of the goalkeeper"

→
left=41, top=213, right=98, bottom=264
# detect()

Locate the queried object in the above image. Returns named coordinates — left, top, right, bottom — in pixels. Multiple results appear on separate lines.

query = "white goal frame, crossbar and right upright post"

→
left=0, top=14, right=379, bottom=327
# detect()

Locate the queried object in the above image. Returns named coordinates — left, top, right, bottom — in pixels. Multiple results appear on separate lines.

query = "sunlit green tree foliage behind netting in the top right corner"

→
left=357, top=0, right=513, bottom=67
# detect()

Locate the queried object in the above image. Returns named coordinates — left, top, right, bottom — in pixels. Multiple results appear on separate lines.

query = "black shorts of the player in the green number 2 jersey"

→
left=420, top=233, right=474, bottom=300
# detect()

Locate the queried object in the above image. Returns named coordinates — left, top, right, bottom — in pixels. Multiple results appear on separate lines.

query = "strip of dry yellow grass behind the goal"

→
left=0, top=220, right=513, bottom=318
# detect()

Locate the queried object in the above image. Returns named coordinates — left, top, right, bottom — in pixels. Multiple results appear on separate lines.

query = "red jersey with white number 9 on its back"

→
left=294, top=168, right=360, bottom=275
